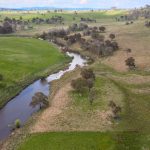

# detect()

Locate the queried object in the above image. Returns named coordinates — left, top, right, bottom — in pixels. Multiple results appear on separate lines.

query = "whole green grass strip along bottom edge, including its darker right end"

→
left=17, top=132, right=150, bottom=150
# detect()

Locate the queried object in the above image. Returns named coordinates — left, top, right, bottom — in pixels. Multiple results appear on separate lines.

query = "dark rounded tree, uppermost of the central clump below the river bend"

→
left=81, top=69, right=95, bottom=80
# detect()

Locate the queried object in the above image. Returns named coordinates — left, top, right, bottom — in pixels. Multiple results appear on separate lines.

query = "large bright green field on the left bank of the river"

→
left=0, top=37, right=69, bottom=106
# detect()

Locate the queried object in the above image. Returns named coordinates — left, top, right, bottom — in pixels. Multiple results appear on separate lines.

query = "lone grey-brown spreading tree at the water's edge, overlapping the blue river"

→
left=30, top=92, right=49, bottom=109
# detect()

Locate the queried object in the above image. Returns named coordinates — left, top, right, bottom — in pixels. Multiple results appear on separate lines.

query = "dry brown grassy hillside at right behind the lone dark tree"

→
left=103, top=21, right=150, bottom=71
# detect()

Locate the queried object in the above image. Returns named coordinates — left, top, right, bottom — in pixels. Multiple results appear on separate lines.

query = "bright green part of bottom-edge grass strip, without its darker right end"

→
left=18, top=132, right=115, bottom=150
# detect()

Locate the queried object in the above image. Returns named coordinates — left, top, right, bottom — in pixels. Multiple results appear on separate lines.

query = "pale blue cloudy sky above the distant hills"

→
left=0, top=0, right=150, bottom=9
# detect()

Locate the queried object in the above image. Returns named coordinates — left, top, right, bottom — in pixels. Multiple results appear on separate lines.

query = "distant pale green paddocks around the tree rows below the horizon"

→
left=0, top=10, right=127, bottom=36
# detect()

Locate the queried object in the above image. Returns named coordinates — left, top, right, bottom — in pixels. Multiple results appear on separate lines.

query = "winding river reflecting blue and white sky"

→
left=0, top=52, right=86, bottom=140
